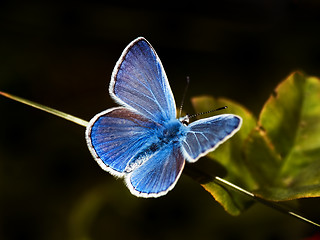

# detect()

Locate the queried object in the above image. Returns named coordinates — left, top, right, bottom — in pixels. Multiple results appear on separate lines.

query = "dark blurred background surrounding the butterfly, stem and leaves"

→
left=0, top=0, right=320, bottom=240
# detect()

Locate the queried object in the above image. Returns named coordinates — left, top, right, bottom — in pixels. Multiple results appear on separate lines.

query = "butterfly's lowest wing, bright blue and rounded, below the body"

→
left=126, top=144, right=185, bottom=197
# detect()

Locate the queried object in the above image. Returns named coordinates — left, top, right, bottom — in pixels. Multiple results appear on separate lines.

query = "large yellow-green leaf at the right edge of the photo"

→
left=244, top=72, right=320, bottom=201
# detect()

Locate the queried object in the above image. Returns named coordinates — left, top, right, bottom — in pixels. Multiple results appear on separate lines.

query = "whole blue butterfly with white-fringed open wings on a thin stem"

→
left=86, top=37, right=242, bottom=197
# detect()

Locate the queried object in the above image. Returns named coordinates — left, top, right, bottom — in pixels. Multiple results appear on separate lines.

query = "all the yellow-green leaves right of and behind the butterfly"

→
left=189, top=72, right=320, bottom=215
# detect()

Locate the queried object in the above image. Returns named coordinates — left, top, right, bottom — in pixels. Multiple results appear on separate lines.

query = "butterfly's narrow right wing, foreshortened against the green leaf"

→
left=182, top=114, right=242, bottom=162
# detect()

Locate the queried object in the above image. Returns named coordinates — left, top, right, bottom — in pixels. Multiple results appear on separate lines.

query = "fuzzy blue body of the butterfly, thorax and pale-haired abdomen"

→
left=125, top=119, right=186, bottom=173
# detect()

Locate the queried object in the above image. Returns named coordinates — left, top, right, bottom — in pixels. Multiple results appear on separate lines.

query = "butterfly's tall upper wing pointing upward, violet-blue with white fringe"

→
left=109, top=37, right=176, bottom=123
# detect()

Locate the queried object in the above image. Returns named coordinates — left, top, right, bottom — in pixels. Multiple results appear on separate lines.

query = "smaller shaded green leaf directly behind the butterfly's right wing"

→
left=189, top=96, right=257, bottom=215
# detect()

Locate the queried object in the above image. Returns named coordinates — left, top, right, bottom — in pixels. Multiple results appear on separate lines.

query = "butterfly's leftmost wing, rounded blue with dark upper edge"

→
left=86, top=107, right=156, bottom=176
